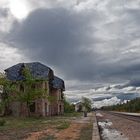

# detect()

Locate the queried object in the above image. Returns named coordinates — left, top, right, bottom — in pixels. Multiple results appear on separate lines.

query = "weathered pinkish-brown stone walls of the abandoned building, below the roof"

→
left=10, top=81, right=64, bottom=116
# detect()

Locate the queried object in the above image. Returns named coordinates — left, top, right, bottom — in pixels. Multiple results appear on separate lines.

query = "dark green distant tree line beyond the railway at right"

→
left=102, top=98, right=140, bottom=112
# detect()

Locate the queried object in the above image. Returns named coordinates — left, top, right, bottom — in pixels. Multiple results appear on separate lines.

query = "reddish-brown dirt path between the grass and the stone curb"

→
left=25, top=113, right=92, bottom=140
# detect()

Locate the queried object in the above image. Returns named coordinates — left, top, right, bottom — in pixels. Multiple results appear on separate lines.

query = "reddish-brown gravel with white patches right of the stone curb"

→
left=97, top=112, right=140, bottom=140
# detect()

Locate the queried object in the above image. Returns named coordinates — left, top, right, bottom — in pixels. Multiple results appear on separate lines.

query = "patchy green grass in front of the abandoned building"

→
left=0, top=113, right=80, bottom=140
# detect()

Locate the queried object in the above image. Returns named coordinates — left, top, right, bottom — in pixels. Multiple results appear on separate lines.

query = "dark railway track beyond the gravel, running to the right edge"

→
left=104, top=111, right=140, bottom=123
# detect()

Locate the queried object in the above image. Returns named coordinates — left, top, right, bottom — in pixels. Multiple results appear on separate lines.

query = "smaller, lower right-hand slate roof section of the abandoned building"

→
left=53, top=76, right=65, bottom=90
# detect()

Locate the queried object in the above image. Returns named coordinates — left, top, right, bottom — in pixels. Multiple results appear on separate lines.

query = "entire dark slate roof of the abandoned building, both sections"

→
left=5, top=62, right=65, bottom=91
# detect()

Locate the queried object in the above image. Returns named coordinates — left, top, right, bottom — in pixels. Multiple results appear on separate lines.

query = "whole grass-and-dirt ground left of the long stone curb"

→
left=0, top=113, right=92, bottom=140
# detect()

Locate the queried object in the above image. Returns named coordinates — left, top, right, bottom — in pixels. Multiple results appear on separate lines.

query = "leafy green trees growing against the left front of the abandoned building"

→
left=0, top=67, right=49, bottom=116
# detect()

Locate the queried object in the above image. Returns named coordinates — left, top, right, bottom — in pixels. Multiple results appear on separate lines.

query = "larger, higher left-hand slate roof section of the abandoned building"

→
left=5, top=62, right=53, bottom=81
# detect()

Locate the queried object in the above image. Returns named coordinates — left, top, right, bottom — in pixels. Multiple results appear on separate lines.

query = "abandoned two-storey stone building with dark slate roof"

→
left=5, top=62, right=65, bottom=116
